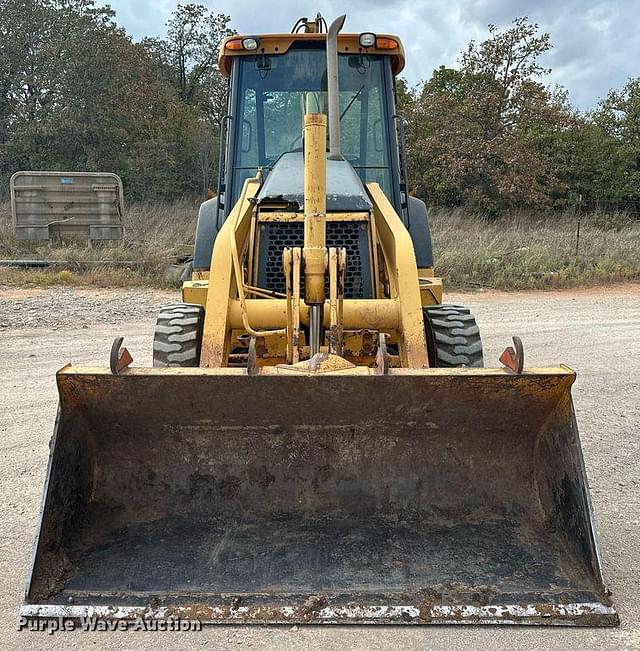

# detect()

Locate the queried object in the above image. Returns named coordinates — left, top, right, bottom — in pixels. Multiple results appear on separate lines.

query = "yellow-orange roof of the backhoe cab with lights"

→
left=218, top=32, right=404, bottom=77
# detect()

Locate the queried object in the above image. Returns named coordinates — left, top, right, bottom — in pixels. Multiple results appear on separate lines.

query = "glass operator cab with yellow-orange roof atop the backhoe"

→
left=218, top=22, right=406, bottom=217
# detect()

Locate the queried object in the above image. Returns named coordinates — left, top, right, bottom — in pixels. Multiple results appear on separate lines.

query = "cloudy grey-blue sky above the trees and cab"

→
left=106, top=0, right=640, bottom=109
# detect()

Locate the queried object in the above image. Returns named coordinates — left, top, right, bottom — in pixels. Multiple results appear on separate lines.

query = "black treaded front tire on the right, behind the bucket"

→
left=422, top=305, right=484, bottom=368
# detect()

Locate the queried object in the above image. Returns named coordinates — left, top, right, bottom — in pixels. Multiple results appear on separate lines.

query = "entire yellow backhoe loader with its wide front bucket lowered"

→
left=21, top=16, right=618, bottom=626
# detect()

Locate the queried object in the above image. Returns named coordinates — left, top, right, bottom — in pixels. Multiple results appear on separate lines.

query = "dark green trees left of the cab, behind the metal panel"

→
left=0, top=0, right=228, bottom=198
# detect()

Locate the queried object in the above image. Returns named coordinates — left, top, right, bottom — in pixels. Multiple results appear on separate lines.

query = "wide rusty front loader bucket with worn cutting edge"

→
left=21, top=367, right=618, bottom=625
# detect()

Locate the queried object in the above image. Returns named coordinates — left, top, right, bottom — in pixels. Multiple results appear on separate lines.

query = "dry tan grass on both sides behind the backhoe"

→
left=0, top=201, right=640, bottom=289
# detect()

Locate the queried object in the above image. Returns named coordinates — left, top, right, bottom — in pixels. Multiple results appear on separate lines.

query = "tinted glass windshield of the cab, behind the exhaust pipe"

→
left=231, top=44, right=391, bottom=205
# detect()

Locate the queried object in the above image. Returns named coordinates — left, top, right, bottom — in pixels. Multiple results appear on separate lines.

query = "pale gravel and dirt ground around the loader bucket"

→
left=0, top=285, right=640, bottom=650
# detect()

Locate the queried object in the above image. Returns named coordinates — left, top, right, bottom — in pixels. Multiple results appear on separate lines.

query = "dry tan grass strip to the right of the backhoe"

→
left=430, top=210, right=640, bottom=289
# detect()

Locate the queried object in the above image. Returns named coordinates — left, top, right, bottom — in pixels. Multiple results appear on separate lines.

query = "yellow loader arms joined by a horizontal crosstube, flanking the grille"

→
left=192, top=178, right=429, bottom=368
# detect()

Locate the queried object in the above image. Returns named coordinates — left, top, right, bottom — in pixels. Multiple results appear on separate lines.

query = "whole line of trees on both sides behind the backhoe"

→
left=0, top=0, right=640, bottom=209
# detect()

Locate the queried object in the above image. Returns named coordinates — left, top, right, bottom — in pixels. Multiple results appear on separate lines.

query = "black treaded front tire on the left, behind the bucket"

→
left=153, top=303, right=204, bottom=367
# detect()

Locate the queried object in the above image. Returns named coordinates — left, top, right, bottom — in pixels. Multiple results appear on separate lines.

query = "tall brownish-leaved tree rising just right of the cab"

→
left=402, top=18, right=567, bottom=214
